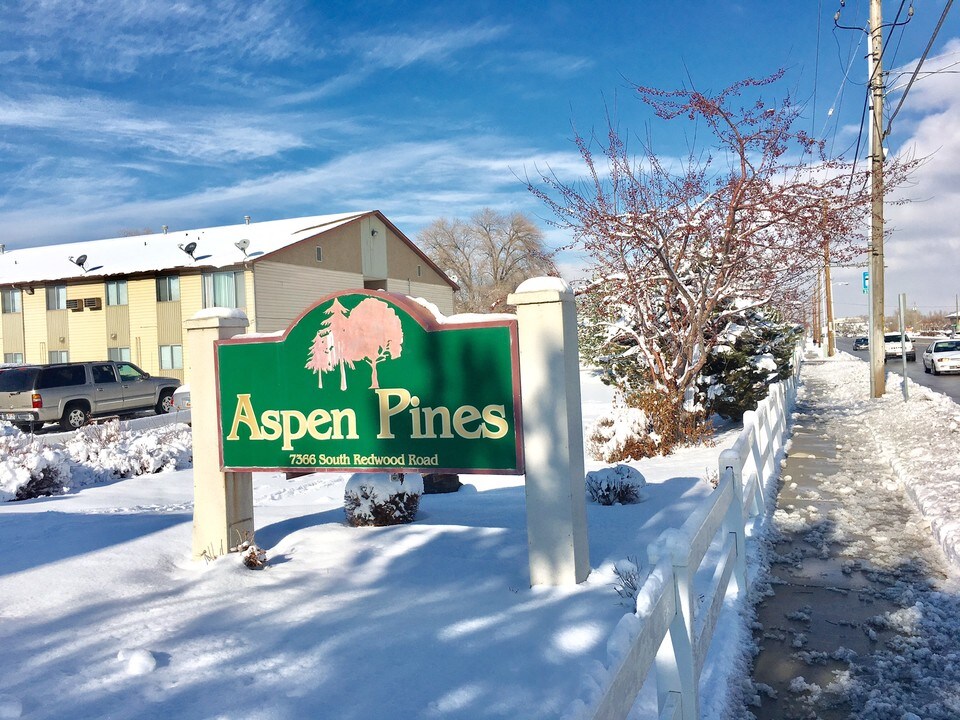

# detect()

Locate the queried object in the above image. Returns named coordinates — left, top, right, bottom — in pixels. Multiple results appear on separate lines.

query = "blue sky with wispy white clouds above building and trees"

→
left=0, top=0, right=960, bottom=315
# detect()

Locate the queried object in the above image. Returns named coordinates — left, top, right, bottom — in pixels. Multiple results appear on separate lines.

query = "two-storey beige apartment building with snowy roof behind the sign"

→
left=0, top=210, right=457, bottom=380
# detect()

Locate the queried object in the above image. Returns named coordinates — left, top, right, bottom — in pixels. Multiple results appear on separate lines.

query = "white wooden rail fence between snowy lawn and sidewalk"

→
left=593, top=350, right=801, bottom=720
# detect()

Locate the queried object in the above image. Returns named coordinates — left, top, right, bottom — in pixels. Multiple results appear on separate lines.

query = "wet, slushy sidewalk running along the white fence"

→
left=742, top=360, right=960, bottom=720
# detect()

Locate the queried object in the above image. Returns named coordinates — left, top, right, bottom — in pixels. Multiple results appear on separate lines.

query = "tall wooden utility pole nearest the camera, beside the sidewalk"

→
left=868, top=0, right=887, bottom=398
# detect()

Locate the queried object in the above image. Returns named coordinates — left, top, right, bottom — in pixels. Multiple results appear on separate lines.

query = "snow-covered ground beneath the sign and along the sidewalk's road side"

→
left=0, top=356, right=960, bottom=720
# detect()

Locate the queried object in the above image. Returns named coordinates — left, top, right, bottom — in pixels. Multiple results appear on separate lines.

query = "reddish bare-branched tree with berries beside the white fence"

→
left=528, top=73, right=912, bottom=408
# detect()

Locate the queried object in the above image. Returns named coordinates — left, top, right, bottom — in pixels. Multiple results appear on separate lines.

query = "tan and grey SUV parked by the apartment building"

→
left=0, top=360, right=180, bottom=430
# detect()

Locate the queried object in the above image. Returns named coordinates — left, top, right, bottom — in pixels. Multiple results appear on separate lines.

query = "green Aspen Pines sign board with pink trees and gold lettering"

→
left=216, top=290, right=523, bottom=473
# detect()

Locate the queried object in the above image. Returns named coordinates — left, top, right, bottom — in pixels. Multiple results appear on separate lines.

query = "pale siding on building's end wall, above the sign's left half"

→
left=253, top=260, right=363, bottom=332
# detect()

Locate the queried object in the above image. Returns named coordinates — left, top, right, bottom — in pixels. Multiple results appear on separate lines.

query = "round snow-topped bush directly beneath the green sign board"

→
left=343, top=473, right=423, bottom=527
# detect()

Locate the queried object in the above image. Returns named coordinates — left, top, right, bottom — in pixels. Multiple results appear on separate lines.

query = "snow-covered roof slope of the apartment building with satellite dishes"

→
left=0, top=211, right=375, bottom=285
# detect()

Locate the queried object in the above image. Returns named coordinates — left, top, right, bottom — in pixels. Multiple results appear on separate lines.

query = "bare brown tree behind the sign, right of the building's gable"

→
left=418, top=208, right=558, bottom=312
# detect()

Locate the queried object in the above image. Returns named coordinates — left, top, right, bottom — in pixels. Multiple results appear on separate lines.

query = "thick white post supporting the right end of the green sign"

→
left=507, top=278, right=590, bottom=585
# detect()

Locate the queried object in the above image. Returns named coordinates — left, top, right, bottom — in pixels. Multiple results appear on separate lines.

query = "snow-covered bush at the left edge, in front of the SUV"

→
left=0, top=425, right=71, bottom=501
